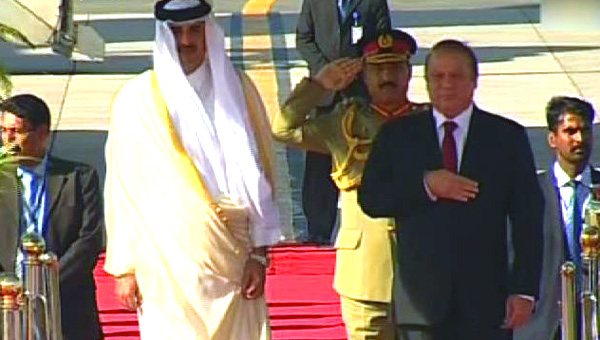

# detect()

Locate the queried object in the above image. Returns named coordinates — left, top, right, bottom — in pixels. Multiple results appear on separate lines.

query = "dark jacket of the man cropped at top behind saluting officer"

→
left=296, top=0, right=391, bottom=104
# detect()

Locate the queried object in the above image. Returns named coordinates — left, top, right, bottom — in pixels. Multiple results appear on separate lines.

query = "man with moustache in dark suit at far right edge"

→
left=515, top=97, right=600, bottom=340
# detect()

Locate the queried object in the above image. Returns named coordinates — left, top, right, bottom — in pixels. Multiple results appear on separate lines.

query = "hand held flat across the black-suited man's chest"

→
left=425, top=169, right=479, bottom=202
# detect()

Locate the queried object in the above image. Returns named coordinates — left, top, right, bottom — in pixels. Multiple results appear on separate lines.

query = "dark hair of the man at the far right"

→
left=546, top=96, right=596, bottom=132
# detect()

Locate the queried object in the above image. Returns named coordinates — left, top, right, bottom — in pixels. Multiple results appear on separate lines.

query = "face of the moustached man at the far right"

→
left=548, top=112, right=594, bottom=170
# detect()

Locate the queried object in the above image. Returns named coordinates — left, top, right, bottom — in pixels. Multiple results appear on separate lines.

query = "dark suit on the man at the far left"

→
left=0, top=158, right=104, bottom=340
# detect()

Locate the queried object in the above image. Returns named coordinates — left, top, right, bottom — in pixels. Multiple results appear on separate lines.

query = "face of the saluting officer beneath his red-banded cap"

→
left=364, top=62, right=411, bottom=109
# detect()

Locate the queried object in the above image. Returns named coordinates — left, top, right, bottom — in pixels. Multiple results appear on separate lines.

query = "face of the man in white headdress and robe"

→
left=169, top=21, right=206, bottom=74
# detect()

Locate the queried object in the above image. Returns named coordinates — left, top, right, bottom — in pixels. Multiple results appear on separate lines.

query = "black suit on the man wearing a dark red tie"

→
left=359, top=107, right=543, bottom=327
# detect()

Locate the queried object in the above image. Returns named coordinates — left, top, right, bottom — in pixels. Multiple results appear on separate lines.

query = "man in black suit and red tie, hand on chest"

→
left=359, top=40, right=543, bottom=340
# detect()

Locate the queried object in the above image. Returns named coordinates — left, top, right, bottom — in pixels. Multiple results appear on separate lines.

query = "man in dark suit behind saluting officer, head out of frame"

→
left=296, top=0, right=390, bottom=244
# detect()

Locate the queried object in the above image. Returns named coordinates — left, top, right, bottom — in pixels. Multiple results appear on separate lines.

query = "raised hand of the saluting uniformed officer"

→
left=315, top=58, right=362, bottom=91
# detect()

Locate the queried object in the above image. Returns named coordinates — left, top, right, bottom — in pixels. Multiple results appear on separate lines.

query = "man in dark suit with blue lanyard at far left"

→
left=0, top=94, right=104, bottom=340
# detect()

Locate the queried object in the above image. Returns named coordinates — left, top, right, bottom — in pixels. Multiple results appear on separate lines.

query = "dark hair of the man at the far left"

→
left=1, top=94, right=50, bottom=129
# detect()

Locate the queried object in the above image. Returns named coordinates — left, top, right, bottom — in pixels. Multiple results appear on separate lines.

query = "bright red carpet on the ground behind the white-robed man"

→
left=95, top=246, right=346, bottom=340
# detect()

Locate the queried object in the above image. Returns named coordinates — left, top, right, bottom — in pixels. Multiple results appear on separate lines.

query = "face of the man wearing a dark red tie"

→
left=425, top=50, right=477, bottom=118
